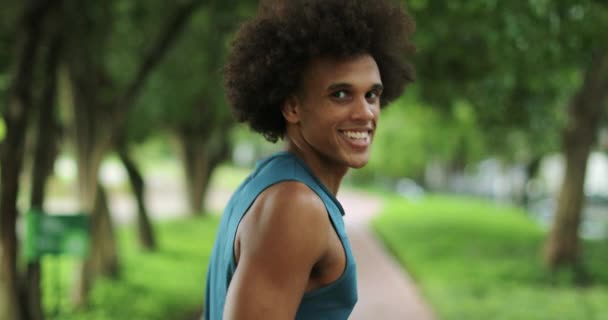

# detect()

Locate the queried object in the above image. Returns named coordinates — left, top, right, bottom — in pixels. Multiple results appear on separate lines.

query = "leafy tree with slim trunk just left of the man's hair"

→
left=131, top=0, right=253, bottom=214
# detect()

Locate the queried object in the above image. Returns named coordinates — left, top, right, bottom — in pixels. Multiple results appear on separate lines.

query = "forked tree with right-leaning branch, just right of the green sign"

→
left=65, top=1, right=201, bottom=304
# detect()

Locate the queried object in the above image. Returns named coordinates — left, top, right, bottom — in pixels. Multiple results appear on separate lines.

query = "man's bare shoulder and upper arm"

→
left=224, top=181, right=329, bottom=320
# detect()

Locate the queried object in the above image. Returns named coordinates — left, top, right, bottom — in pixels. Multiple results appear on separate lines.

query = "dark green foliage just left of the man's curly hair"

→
left=129, top=1, right=253, bottom=141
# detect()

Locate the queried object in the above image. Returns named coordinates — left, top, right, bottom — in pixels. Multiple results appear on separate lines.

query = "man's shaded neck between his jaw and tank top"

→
left=285, top=136, right=348, bottom=196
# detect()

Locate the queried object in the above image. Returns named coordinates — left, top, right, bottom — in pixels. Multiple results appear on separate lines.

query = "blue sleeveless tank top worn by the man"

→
left=205, top=152, right=357, bottom=320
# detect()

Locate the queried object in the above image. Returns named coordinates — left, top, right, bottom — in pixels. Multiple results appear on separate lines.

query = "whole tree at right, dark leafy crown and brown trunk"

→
left=410, top=0, right=608, bottom=268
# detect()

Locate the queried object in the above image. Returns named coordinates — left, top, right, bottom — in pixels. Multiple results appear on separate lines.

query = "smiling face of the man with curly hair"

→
left=283, top=55, right=382, bottom=168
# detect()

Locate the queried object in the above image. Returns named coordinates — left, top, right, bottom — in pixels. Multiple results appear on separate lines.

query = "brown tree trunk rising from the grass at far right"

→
left=545, top=54, right=608, bottom=269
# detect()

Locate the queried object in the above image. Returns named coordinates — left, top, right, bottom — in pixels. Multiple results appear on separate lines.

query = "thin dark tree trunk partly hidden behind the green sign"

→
left=24, top=26, right=60, bottom=320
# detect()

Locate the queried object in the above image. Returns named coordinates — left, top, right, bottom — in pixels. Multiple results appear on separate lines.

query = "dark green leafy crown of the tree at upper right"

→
left=408, top=0, right=608, bottom=160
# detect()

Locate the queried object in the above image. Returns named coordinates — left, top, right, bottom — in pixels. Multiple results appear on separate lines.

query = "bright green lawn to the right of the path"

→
left=373, top=196, right=608, bottom=320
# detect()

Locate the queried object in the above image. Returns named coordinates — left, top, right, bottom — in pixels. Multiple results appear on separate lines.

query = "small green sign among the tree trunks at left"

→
left=24, top=209, right=89, bottom=261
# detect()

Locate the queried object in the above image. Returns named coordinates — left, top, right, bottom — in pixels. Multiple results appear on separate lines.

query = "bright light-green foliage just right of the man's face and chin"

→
left=355, top=92, right=485, bottom=178
